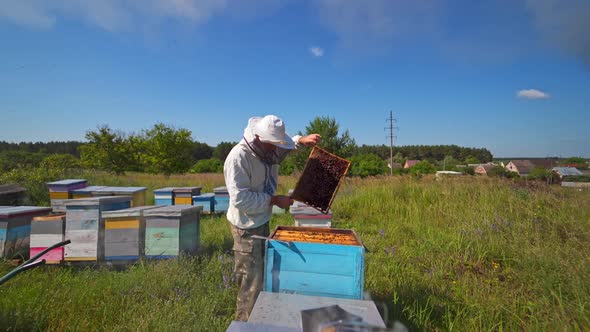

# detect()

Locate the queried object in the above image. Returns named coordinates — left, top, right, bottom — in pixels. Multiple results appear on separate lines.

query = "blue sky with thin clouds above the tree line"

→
left=0, top=0, right=590, bottom=157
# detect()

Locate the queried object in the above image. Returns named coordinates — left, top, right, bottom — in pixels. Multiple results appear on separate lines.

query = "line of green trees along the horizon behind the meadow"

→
left=0, top=117, right=493, bottom=176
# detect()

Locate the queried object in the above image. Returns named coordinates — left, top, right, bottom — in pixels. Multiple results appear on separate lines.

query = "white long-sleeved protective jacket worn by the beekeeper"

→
left=223, top=135, right=301, bottom=229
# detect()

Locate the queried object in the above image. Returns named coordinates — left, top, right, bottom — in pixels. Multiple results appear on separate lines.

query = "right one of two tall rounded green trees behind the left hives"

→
left=140, top=123, right=193, bottom=175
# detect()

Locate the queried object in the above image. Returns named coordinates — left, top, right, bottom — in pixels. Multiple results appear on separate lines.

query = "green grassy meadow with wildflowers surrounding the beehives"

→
left=0, top=173, right=590, bottom=331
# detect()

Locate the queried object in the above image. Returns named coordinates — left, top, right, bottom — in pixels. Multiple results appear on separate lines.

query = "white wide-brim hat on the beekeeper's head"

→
left=245, top=115, right=295, bottom=150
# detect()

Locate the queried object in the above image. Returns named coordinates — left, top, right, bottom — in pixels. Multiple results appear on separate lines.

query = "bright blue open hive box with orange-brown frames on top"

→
left=264, top=226, right=365, bottom=300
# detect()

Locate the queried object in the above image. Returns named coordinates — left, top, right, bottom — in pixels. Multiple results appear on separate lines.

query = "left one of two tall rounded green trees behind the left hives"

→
left=79, top=125, right=136, bottom=174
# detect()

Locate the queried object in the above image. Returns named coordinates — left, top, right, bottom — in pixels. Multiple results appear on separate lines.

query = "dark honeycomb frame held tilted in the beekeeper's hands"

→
left=291, top=146, right=350, bottom=213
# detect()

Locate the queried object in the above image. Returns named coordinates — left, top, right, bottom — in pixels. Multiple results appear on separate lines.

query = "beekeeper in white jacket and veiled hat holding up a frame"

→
left=223, top=115, right=320, bottom=321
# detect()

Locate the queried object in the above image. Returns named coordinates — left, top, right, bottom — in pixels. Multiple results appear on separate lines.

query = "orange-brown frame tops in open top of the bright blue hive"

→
left=269, top=226, right=364, bottom=247
